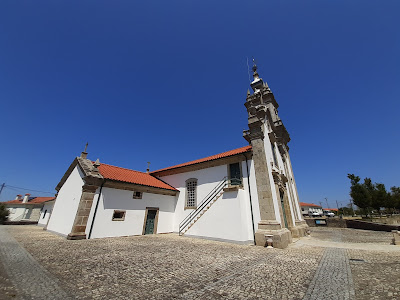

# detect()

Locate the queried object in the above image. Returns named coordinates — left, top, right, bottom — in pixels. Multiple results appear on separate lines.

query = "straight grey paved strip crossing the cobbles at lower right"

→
left=304, top=248, right=355, bottom=300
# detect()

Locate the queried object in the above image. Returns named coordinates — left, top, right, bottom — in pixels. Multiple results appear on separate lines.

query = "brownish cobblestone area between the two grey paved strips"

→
left=3, top=226, right=324, bottom=299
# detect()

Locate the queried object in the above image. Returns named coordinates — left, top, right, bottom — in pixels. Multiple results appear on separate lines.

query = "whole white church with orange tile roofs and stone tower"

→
left=45, top=65, right=307, bottom=248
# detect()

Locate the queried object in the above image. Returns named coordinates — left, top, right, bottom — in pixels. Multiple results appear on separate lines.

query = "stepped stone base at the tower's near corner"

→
left=255, top=221, right=292, bottom=249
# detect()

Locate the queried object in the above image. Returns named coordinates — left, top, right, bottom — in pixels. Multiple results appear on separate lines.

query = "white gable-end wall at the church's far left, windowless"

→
left=47, top=166, right=84, bottom=235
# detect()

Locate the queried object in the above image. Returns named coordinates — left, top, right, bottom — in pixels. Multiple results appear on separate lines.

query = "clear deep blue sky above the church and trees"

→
left=0, top=0, right=400, bottom=207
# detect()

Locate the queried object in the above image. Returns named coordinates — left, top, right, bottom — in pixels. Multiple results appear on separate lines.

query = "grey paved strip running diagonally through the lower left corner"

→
left=0, top=226, right=70, bottom=299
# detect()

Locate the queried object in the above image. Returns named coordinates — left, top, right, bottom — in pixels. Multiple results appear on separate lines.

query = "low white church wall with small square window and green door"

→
left=86, top=187, right=175, bottom=238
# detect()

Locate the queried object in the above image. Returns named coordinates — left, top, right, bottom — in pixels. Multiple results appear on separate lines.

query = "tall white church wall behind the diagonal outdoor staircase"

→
left=161, top=160, right=259, bottom=242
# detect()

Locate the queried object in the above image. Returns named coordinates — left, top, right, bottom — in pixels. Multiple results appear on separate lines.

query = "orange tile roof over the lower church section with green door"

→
left=99, top=164, right=177, bottom=191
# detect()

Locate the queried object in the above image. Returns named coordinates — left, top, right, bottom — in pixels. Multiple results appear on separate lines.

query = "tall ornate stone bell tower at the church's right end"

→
left=243, top=64, right=307, bottom=248
